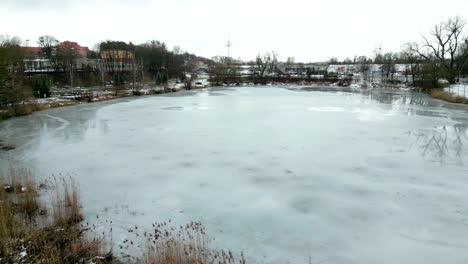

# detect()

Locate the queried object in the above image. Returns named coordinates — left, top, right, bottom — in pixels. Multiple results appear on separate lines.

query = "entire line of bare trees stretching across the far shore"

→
left=0, top=17, right=468, bottom=106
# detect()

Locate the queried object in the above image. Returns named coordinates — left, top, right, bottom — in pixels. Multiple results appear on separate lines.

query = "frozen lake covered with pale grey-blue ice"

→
left=0, top=87, right=468, bottom=264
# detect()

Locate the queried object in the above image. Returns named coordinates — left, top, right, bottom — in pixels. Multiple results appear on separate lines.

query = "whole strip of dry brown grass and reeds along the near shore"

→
left=0, top=168, right=246, bottom=264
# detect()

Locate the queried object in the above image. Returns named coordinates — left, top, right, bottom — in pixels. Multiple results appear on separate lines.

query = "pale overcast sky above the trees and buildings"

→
left=0, top=0, right=468, bottom=62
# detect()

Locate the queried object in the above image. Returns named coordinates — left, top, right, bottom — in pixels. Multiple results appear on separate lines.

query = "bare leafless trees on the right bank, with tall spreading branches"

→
left=328, top=17, right=468, bottom=88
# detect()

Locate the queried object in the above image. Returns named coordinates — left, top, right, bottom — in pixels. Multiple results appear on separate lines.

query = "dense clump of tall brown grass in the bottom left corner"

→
left=0, top=168, right=114, bottom=264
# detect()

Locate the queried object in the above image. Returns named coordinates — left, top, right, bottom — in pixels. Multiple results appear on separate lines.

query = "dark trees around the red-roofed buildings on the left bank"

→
left=0, top=35, right=206, bottom=106
